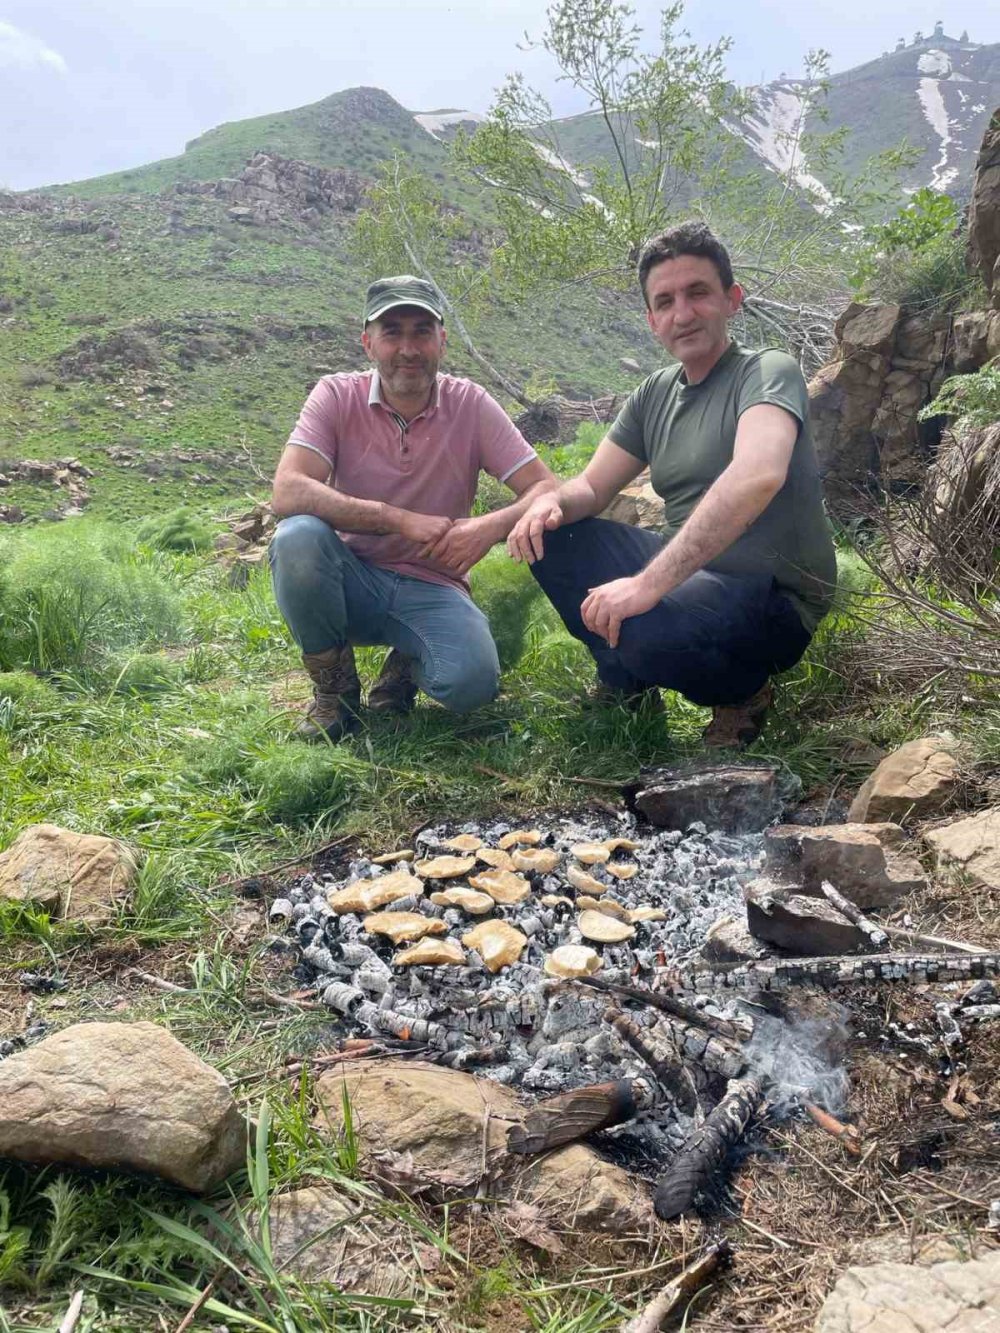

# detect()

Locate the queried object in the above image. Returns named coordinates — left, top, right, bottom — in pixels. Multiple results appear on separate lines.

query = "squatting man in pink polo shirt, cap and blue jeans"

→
left=271, top=275, right=557, bottom=741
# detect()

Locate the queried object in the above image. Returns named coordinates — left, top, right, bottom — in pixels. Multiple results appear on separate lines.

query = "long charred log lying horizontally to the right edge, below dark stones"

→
left=671, top=953, right=1000, bottom=993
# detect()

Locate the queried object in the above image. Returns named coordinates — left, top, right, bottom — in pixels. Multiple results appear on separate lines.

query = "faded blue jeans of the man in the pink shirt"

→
left=271, top=515, right=500, bottom=713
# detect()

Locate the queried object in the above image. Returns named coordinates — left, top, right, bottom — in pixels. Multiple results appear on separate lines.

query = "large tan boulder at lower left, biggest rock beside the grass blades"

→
left=0, top=1022, right=247, bottom=1193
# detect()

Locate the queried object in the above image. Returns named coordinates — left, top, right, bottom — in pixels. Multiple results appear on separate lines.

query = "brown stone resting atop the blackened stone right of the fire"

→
left=764, top=824, right=927, bottom=912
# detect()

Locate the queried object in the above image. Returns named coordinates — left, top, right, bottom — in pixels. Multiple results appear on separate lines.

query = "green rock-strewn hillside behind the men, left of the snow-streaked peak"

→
left=0, top=88, right=659, bottom=517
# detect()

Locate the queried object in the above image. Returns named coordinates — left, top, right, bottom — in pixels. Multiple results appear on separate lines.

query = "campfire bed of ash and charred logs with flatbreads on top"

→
left=271, top=789, right=890, bottom=1217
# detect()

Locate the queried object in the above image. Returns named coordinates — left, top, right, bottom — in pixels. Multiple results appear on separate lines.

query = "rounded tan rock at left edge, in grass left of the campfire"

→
left=0, top=824, right=136, bottom=922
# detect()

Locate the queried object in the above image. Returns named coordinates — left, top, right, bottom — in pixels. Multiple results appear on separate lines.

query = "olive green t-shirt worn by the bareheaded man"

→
left=608, top=343, right=837, bottom=633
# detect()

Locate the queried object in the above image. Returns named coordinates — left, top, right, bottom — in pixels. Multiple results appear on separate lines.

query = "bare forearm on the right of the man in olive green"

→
left=639, top=469, right=780, bottom=597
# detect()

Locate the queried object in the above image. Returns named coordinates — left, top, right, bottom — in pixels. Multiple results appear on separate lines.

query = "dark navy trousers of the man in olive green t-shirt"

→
left=531, top=519, right=811, bottom=705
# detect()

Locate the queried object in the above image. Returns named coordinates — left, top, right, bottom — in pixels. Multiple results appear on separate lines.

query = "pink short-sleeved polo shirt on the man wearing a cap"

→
left=288, top=371, right=536, bottom=592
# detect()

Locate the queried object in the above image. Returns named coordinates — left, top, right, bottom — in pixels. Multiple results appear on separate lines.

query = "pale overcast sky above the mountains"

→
left=0, top=0, right=1000, bottom=189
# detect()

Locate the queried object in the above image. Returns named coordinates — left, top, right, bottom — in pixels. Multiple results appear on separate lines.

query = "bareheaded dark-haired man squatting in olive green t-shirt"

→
left=507, top=223, right=836, bottom=745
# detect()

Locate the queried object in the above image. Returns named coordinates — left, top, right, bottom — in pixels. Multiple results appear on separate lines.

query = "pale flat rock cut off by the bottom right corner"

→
left=816, top=1250, right=1000, bottom=1333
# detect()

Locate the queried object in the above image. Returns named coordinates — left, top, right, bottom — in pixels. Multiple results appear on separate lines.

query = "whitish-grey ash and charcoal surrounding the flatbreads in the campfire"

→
left=269, top=814, right=763, bottom=1157
